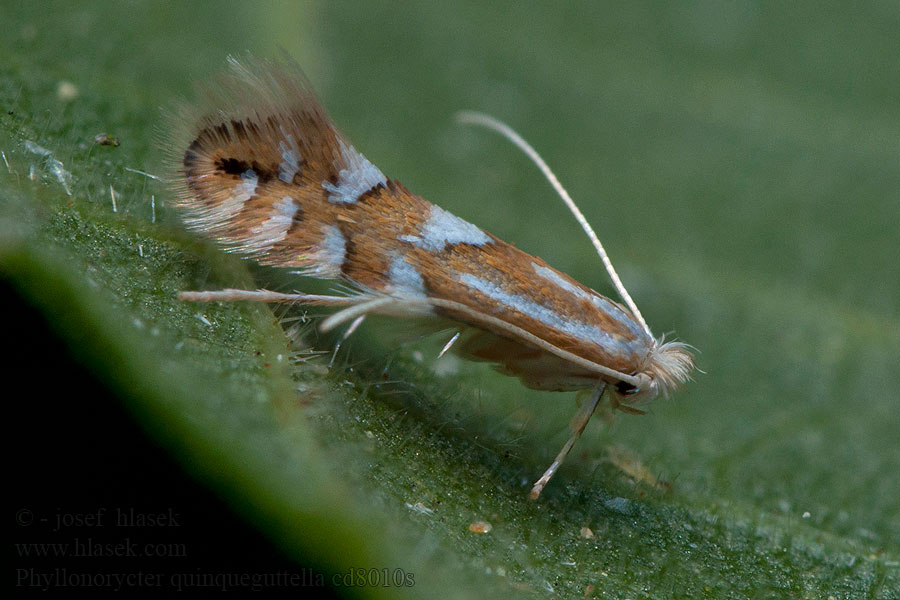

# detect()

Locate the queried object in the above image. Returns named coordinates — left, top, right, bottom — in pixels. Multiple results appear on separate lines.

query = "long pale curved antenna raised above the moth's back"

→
left=456, top=110, right=653, bottom=338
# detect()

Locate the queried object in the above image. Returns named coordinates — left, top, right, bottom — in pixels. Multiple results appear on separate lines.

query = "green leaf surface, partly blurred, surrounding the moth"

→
left=0, top=1, right=900, bottom=598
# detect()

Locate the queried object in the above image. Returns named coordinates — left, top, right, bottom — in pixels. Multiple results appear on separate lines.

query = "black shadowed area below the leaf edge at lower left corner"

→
left=6, top=283, right=336, bottom=597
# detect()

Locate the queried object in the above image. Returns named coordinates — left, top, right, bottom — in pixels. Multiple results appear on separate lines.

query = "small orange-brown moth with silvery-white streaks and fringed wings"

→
left=170, top=58, right=693, bottom=498
